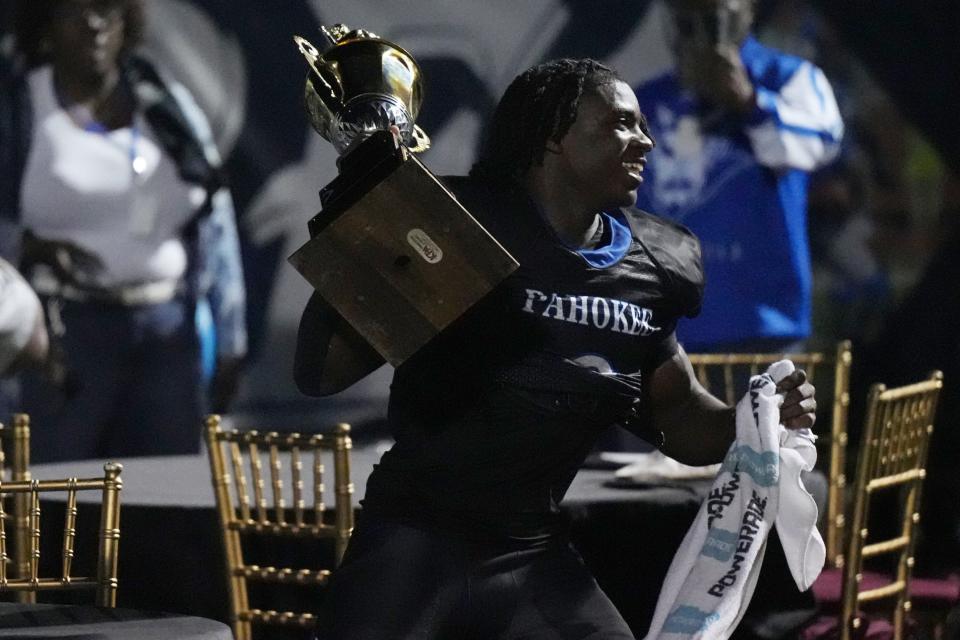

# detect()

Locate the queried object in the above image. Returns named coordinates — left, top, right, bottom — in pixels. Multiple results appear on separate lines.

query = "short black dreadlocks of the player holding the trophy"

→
left=470, top=58, right=620, bottom=186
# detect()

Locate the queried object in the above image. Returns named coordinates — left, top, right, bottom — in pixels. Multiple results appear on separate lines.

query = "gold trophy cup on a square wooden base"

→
left=288, top=25, right=518, bottom=366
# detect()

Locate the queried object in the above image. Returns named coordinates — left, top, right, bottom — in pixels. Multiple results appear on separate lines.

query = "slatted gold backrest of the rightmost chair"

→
left=841, top=371, right=943, bottom=640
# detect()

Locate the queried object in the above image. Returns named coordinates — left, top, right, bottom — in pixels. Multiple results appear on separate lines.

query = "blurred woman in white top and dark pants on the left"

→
left=0, top=0, right=246, bottom=461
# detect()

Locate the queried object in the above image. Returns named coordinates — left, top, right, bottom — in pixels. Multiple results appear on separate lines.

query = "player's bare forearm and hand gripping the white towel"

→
left=648, top=346, right=817, bottom=465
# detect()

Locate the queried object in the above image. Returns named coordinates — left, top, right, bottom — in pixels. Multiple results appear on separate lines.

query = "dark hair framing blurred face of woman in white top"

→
left=13, top=0, right=145, bottom=68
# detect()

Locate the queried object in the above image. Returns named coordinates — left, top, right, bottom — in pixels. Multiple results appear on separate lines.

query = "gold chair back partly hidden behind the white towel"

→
left=688, top=340, right=853, bottom=568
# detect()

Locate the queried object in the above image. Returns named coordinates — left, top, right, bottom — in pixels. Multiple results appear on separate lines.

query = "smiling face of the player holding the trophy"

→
left=558, top=80, right=654, bottom=210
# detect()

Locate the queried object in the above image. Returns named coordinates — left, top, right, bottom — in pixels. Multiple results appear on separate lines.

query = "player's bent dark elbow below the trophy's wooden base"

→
left=293, top=293, right=384, bottom=396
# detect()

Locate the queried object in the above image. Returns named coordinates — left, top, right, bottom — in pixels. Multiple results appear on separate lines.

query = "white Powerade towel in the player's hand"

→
left=646, top=360, right=826, bottom=640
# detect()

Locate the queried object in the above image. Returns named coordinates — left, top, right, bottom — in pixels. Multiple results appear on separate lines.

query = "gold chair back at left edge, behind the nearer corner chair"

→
left=0, top=413, right=37, bottom=602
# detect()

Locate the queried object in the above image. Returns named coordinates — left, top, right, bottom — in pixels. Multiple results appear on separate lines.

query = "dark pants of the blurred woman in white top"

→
left=21, top=299, right=203, bottom=462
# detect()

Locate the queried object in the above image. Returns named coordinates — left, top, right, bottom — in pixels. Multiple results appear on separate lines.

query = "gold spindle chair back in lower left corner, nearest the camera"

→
left=0, top=463, right=122, bottom=607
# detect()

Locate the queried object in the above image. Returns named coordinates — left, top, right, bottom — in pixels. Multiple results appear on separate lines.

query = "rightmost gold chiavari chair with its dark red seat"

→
left=801, top=371, right=944, bottom=640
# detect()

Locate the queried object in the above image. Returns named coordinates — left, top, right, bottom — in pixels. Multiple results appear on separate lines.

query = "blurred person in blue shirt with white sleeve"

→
left=637, top=0, right=843, bottom=352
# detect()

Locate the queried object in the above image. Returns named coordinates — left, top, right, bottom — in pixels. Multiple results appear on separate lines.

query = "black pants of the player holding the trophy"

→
left=318, top=514, right=633, bottom=640
